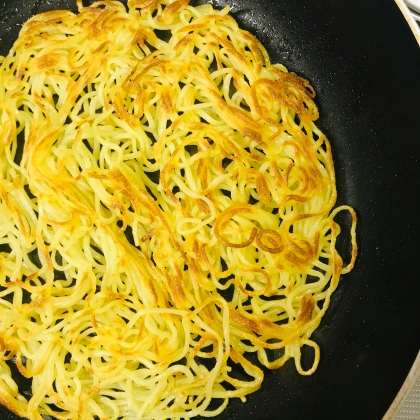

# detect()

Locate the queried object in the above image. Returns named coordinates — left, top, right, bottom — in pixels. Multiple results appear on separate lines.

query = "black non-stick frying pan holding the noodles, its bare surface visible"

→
left=0, top=0, right=420, bottom=420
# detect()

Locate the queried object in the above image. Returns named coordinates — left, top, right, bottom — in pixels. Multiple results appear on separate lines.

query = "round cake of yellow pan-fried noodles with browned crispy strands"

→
left=0, top=0, right=357, bottom=420
